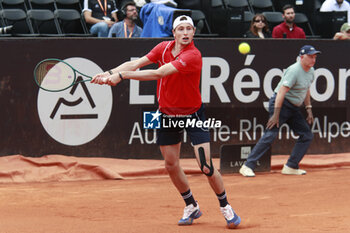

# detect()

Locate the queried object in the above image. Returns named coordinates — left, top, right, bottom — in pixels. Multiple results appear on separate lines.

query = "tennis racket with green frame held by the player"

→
left=34, top=58, right=92, bottom=92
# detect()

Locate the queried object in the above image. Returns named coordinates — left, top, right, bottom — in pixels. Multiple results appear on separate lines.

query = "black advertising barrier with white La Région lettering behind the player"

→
left=0, top=38, right=350, bottom=159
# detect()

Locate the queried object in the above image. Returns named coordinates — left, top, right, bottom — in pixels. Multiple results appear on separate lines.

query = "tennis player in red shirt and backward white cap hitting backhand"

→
left=91, top=15, right=241, bottom=228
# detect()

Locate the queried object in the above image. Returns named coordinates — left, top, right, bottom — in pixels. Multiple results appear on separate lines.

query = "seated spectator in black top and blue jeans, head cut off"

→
left=83, top=0, right=118, bottom=37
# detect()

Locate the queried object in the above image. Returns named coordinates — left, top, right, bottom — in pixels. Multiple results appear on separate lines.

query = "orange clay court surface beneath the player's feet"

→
left=0, top=153, right=350, bottom=233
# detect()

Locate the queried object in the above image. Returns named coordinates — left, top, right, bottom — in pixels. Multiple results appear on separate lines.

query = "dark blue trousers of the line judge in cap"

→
left=245, top=94, right=313, bottom=170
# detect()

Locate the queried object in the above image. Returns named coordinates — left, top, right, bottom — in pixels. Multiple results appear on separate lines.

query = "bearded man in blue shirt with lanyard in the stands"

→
left=108, top=2, right=142, bottom=38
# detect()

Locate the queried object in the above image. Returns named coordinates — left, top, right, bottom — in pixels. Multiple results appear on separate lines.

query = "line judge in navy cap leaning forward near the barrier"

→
left=239, top=45, right=321, bottom=177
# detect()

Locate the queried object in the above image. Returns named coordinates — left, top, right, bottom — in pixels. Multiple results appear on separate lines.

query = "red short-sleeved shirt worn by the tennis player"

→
left=146, top=41, right=202, bottom=115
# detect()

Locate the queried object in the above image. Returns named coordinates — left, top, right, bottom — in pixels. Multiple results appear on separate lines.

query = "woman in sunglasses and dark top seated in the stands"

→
left=244, top=14, right=271, bottom=39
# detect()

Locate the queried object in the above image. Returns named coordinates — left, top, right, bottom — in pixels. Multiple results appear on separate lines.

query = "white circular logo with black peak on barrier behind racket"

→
left=38, top=57, right=113, bottom=146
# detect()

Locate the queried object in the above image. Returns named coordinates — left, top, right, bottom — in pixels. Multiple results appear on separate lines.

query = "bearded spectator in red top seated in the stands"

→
left=272, top=4, right=305, bottom=39
